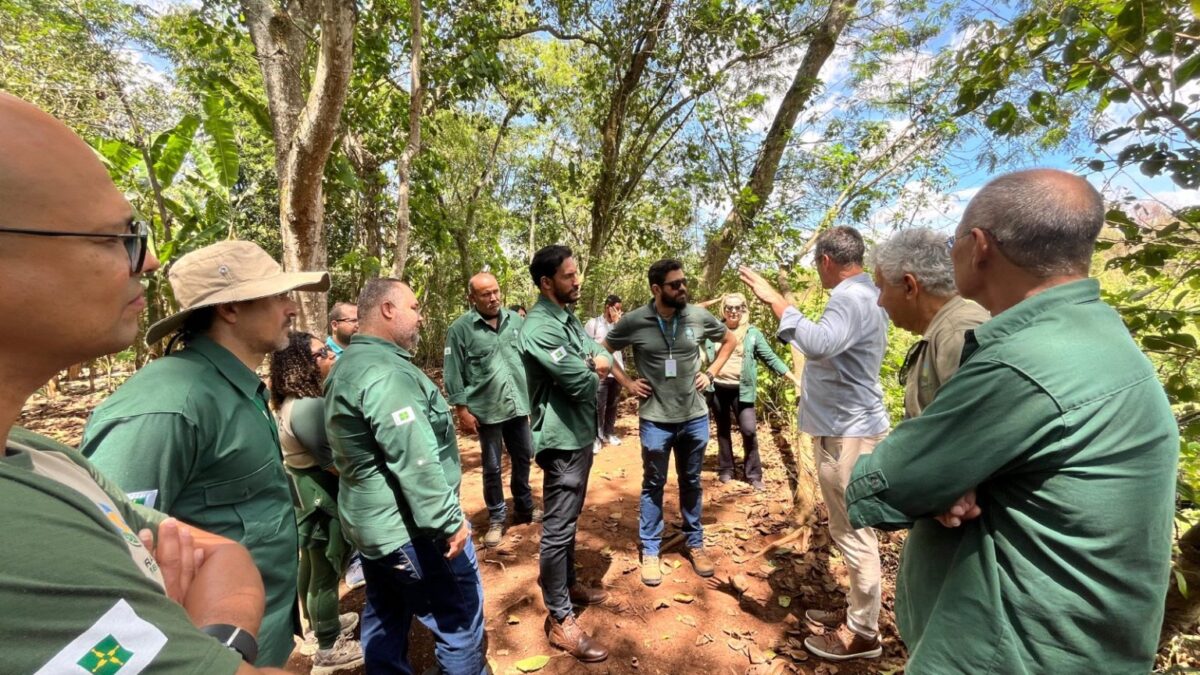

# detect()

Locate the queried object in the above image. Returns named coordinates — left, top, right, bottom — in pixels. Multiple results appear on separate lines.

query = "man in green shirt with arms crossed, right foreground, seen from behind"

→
left=846, top=169, right=1180, bottom=675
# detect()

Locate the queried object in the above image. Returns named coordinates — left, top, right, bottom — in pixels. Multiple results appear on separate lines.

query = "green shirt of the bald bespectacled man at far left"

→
left=0, top=429, right=241, bottom=675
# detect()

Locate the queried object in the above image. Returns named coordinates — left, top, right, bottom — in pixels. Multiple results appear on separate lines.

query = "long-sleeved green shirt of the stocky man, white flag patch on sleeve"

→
left=325, top=333, right=463, bottom=560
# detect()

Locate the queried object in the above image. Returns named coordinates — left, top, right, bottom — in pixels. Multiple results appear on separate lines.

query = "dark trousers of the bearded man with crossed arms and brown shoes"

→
left=538, top=447, right=593, bottom=621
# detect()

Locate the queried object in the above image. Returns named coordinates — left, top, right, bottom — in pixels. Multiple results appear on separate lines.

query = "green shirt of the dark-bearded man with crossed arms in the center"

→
left=520, top=297, right=612, bottom=453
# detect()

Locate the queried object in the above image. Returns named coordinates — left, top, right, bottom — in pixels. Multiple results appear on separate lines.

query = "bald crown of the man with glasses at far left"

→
left=0, top=94, right=131, bottom=231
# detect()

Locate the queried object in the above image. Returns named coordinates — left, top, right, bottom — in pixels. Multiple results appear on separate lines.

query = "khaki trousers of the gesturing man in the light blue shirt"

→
left=812, top=434, right=886, bottom=638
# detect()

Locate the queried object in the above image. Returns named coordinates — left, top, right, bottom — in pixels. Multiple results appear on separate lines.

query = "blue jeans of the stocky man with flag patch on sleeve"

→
left=362, top=539, right=487, bottom=675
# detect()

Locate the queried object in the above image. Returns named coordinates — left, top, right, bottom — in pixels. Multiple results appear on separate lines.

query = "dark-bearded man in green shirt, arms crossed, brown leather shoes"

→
left=521, top=244, right=612, bottom=662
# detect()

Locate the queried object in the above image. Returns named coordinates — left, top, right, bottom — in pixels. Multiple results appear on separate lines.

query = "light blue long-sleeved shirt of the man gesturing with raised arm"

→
left=778, top=274, right=889, bottom=436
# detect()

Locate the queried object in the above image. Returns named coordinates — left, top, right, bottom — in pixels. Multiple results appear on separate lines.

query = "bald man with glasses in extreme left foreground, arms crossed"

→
left=0, top=94, right=290, bottom=675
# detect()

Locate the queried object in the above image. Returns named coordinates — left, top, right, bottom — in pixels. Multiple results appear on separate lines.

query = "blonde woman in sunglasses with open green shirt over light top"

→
left=704, top=293, right=799, bottom=492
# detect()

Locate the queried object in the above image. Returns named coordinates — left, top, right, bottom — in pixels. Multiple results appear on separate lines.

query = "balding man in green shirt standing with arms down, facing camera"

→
left=444, top=271, right=541, bottom=548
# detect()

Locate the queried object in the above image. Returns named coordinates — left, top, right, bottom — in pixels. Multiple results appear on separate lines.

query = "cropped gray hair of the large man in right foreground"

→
left=959, top=169, right=1104, bottom=279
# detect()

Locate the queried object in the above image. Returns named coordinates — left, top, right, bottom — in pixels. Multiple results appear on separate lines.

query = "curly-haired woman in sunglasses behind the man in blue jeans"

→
left=271, top=331, right=362, bottom=675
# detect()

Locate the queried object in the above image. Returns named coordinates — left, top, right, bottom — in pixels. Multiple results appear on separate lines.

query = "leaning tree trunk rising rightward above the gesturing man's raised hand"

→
left=701, top=0, right=858, bottom=295
